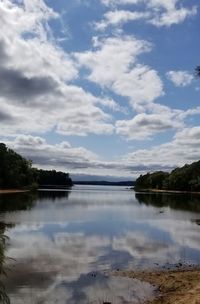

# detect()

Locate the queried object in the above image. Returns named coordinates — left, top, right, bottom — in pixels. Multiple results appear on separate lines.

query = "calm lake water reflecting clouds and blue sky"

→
left=0, top=186, right=200, bottom=304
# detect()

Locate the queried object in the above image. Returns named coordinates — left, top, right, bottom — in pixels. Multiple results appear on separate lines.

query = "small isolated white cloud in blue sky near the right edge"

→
left=166, top=71, right=194, bottom=87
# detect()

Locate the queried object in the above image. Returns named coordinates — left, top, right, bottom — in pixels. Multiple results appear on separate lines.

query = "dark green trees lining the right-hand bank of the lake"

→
left=135, top=161, right=200, bottom=191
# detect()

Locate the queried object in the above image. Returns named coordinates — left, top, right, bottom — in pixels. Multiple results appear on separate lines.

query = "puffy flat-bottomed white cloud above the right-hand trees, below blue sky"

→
left=115, top=103, right=200, bottom=141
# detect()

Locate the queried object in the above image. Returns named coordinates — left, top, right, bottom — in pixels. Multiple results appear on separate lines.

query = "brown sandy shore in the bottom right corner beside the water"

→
left=114, top=268, right=200, bottom=304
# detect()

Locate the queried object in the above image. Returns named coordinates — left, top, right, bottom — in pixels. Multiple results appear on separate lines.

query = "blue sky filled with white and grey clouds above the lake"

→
left=0, top=0, right=200, bottom=179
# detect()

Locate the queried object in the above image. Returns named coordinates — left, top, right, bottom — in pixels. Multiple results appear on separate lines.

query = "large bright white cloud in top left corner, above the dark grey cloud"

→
left=0, top=0, right=78, bottom=80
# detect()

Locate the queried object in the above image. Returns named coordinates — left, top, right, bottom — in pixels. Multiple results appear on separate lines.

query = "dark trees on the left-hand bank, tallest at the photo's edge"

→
left=0, top=143, right=72, bottom=188
